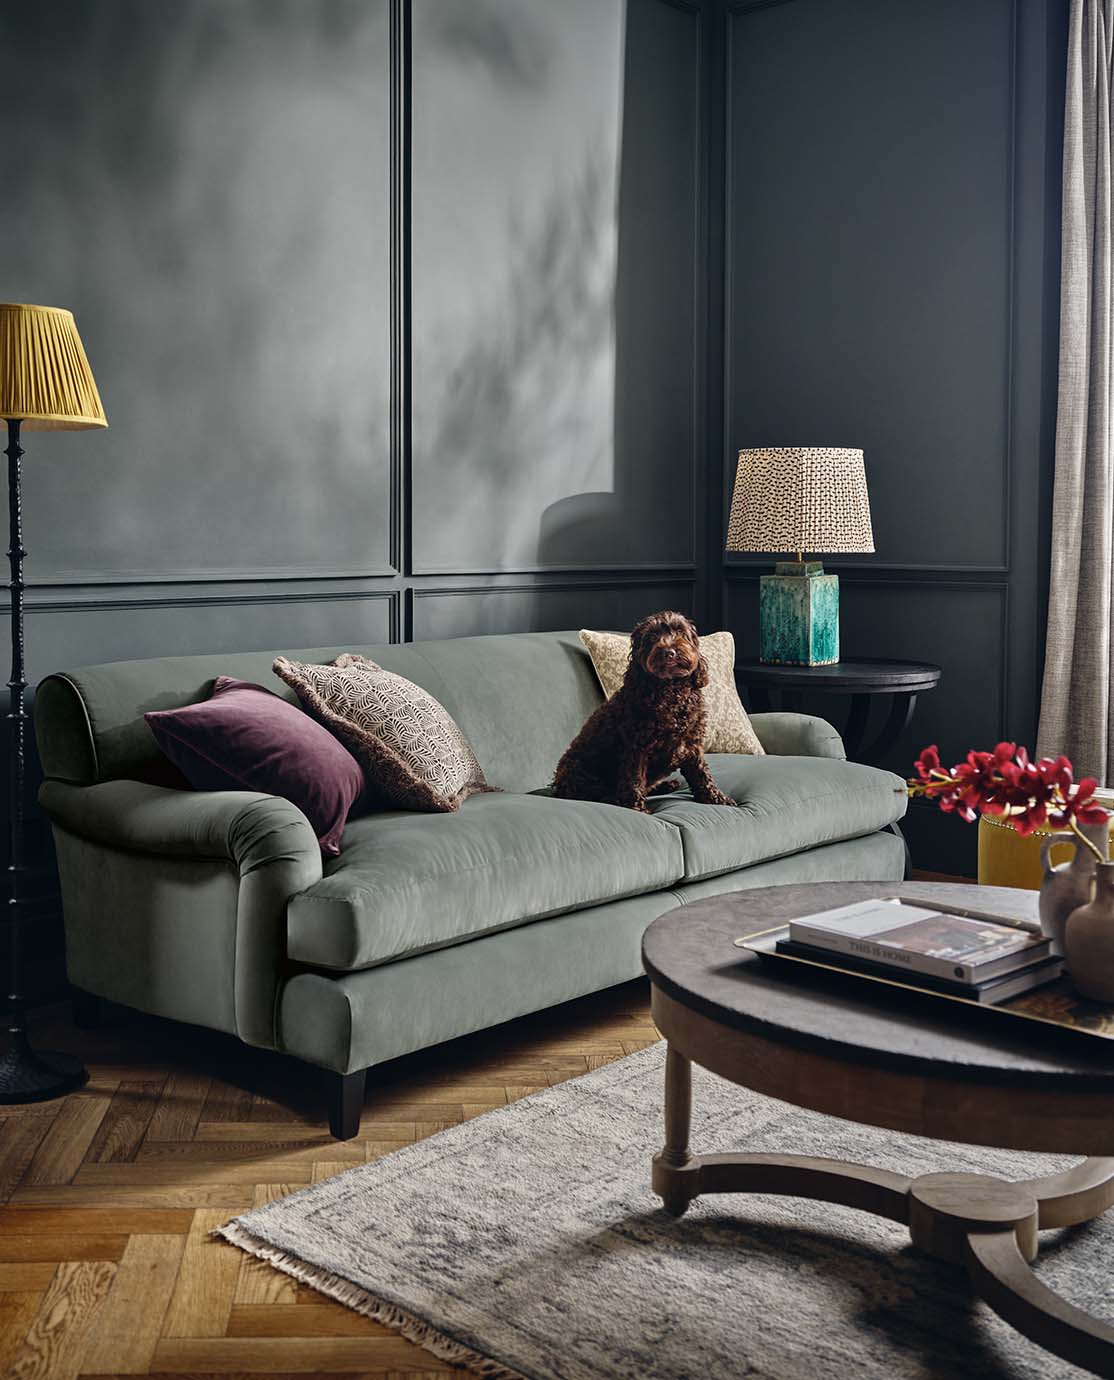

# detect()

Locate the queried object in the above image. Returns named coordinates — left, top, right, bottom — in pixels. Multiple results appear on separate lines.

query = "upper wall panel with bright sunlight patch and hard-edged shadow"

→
left=411, top=0, right=703, bottom=574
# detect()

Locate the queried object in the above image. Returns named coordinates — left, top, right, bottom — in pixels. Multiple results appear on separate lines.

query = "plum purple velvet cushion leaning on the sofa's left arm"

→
left=144, top=676, right=363, bottom=857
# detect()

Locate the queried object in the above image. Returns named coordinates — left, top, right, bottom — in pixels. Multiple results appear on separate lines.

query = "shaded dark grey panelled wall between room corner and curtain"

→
left=723, top=0, right=1067, bottom=874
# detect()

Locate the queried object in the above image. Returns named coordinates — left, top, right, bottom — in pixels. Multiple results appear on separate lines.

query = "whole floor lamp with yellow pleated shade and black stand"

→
left=0, top=302, right=108, bottom=1103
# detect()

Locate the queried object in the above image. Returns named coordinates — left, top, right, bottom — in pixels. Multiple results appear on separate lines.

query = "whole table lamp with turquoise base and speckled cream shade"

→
left=727, top=446, right=874, bottom=667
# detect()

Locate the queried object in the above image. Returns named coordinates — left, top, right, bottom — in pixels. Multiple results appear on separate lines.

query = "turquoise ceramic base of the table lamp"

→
left=759, top=560, right=839, bottom=667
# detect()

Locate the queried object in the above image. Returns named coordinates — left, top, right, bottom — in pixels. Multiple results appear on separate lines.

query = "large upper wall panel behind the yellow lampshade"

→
left=0, top=0, right=391, bottom=582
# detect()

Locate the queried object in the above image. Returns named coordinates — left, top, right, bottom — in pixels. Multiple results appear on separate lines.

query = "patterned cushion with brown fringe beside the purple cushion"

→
left=273, top=653, right=489, bottom=811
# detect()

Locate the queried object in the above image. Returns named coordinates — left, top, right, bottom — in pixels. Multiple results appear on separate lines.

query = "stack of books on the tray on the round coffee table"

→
left=777, top=897, right=1063, bottom=1006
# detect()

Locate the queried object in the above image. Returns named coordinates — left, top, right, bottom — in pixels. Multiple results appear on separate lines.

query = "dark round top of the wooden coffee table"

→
left=642, top=882, right=1114, bottom=1093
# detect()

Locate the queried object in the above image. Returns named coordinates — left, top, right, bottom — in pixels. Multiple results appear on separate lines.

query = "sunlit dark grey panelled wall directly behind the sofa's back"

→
left=0, top=0, right=705, bottom=690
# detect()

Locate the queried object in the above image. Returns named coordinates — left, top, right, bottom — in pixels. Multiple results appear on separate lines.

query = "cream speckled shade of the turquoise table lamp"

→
left=727, top=446, right=874, bottom=553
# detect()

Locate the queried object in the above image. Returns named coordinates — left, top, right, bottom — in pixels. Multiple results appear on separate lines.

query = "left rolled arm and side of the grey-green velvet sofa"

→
left=39, top=781, right=322, bottom=1046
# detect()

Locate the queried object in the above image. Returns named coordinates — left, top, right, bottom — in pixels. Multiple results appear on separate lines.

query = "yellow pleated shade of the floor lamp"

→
left=0, top=302, right=108, bottom=431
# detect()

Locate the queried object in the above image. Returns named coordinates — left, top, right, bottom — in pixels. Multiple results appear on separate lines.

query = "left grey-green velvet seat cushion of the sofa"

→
left=287, top=792, right=685, bottom=971
